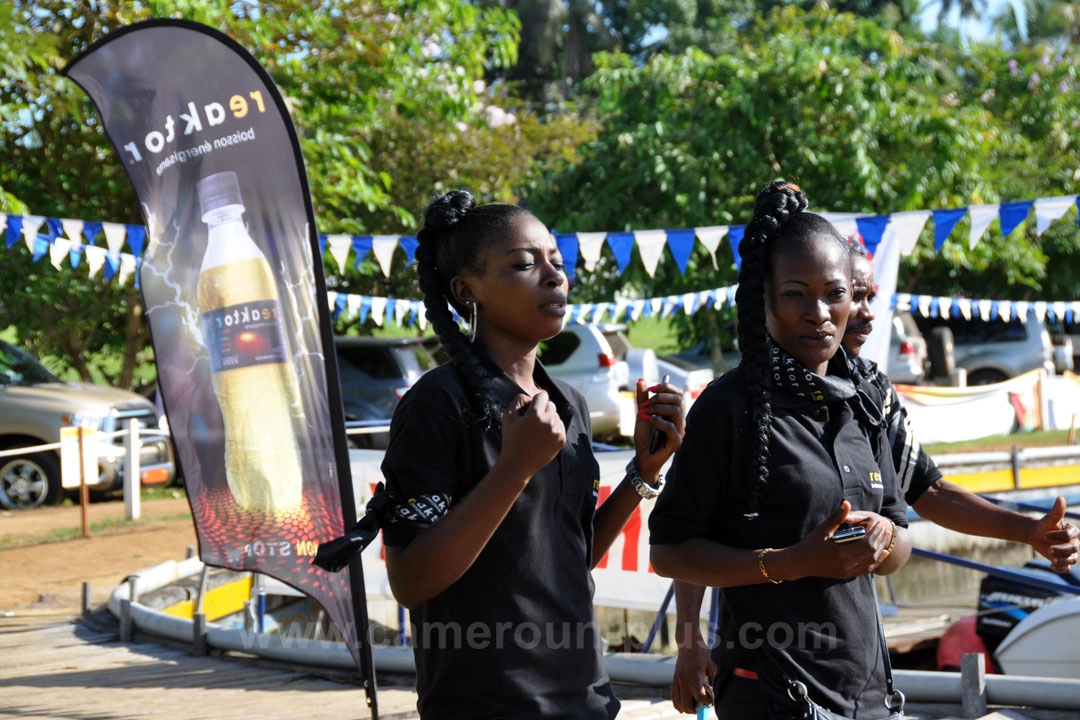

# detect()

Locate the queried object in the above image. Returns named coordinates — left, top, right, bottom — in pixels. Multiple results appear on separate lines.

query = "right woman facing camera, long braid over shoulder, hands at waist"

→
left=649, top=181, right=910, bottom=720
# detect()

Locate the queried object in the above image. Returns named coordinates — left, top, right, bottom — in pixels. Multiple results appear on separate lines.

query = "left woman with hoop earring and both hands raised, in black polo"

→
left=382, top=191, right=685, bottom=720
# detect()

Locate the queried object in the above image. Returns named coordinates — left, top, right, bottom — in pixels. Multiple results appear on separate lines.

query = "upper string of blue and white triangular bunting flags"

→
left=6, top=195, right=1080, bottom=277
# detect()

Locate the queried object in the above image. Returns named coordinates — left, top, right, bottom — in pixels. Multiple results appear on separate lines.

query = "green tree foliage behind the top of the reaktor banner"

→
left=0, top=0, right=589, bottom=386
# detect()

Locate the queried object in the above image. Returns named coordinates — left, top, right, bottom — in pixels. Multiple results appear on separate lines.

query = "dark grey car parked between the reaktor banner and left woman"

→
left=334, top=336, right=440, bottom=449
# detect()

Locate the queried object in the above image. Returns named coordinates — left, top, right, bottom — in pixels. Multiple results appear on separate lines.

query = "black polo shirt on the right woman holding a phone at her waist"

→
left=649, top=361, right=907, bottom=718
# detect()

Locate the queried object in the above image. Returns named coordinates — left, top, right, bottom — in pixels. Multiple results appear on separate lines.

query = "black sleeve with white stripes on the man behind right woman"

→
left=851, top=356, right=942, bottom=505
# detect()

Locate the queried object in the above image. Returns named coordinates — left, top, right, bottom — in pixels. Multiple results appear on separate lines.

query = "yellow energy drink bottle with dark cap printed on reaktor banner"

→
left=197, top=172, right=303, bottom=514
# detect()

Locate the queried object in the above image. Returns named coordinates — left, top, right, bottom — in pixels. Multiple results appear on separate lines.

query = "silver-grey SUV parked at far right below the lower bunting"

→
left=915, top=311, right=1055, bottom=385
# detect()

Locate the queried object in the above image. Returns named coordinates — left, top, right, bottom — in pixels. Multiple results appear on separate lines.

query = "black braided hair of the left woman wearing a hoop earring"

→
left=416, top=190, right=529, bottom=429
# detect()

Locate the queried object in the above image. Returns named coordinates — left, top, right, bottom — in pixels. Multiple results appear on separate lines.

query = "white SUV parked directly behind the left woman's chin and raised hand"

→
left=540, top=324, right=634, bottom=439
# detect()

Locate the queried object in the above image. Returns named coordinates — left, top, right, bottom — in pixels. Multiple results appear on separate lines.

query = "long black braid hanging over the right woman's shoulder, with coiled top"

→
left=735, top=181, right=807, bottom=515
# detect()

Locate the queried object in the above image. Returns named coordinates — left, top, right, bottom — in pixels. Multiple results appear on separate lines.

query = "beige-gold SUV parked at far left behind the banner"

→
left=0, top=341, right=176, bottom=510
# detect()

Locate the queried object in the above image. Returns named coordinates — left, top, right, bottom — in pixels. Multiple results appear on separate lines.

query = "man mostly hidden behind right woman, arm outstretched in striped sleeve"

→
left=672, top=237, right=1080, bottom=712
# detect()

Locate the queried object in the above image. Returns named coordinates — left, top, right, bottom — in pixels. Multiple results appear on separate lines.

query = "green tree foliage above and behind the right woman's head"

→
left=518, top=8, right=1080, bottom=342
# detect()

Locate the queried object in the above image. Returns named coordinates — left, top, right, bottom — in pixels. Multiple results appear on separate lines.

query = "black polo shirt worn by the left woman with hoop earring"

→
left=382, top=359, right=619, bottom=719
